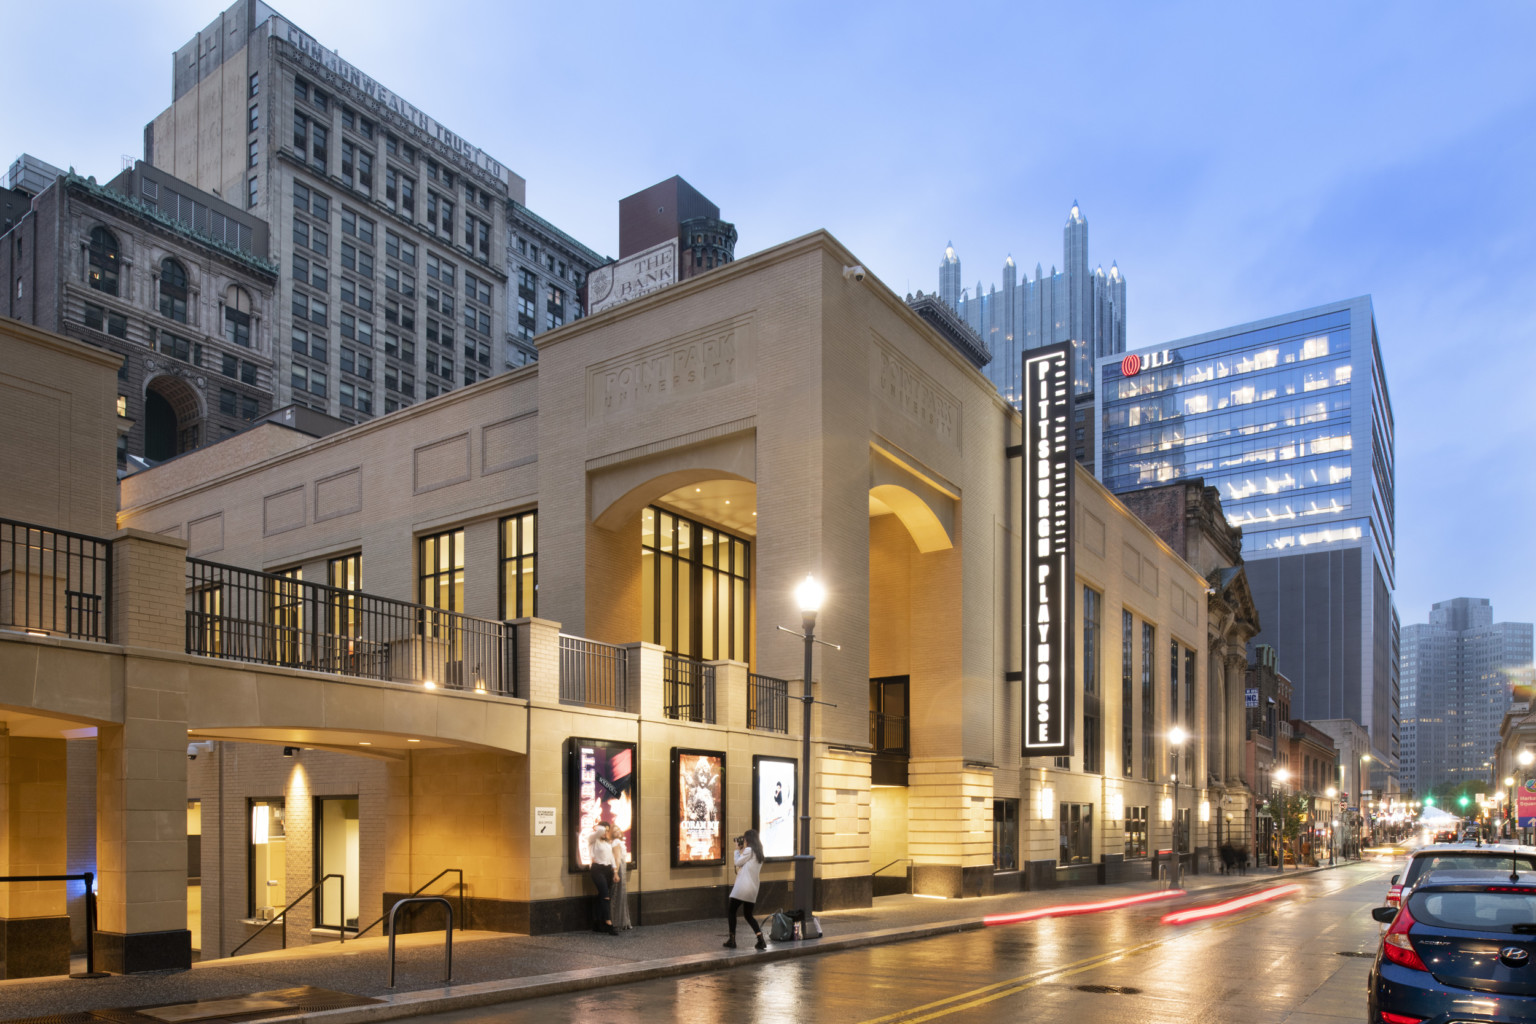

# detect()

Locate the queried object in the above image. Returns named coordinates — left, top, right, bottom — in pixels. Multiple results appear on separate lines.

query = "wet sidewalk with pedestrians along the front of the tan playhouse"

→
left=0, top=861, right=1385, bottom=1024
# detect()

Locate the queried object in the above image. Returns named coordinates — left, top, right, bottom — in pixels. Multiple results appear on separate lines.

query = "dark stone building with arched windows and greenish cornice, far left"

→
left=0, top=158, right=278, bottom=467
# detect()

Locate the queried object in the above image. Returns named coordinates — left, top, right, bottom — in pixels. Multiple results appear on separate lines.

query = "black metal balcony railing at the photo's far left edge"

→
left=0, top=519, right=112, bottom=640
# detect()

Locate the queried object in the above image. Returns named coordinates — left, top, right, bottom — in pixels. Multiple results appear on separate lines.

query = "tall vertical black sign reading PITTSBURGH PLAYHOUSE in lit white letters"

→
left=1021, top=342, right=1075, bottom=757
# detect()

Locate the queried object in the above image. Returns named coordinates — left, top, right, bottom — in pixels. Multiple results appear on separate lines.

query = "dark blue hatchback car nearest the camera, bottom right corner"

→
left=1369, top=870, right=1536, bottom=1024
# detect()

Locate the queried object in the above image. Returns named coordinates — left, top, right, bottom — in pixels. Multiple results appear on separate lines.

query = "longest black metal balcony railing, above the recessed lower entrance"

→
left=186, top=559, right=525, bottom=697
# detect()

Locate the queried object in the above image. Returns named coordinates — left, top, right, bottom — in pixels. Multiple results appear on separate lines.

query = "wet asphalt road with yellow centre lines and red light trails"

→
left=419, top=863, right=1392, bottom=1024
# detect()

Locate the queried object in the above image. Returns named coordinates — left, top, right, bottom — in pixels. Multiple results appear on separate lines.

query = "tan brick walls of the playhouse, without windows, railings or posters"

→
left=0, top=233, right=1209, bottom=976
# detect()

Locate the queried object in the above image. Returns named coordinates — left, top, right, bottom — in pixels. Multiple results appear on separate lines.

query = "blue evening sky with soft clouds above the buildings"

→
left=12, top=0, right=1536, bottom=623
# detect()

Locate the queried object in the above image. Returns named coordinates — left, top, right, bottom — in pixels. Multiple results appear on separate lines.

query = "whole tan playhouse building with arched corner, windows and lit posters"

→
left=0, top=232, right=1226, bottom=963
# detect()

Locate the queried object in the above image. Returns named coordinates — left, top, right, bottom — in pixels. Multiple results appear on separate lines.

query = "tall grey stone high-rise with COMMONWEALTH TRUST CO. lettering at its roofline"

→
left=144, top=0, right=525, bottom=422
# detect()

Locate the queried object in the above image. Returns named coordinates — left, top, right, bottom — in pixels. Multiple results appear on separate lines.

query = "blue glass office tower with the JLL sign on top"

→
left=1095, top=296, right=1399, bottom=776
